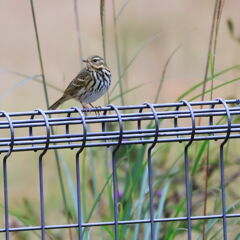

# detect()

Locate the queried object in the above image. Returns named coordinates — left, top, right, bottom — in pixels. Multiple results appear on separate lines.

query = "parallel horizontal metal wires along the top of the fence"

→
left=0, top=100, right=240, bottom=152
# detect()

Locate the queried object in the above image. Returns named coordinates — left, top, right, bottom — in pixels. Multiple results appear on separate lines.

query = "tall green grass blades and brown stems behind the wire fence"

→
left=0, top=0, right=240, bottom=240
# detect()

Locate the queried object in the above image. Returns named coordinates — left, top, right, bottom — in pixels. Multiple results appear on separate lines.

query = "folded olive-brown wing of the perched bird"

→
left=64, top=68, right=91, bottom=97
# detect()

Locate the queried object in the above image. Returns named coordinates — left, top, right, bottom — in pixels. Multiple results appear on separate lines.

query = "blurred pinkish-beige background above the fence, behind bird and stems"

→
left=0, top=0, right=240, bottom=111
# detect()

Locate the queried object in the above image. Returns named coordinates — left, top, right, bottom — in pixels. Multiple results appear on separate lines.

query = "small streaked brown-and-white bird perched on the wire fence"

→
left=48, top=55, right=111, bottom=110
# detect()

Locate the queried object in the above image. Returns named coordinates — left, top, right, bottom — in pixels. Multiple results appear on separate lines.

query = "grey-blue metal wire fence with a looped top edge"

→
left=0, top=99, right=240, bottom=239
